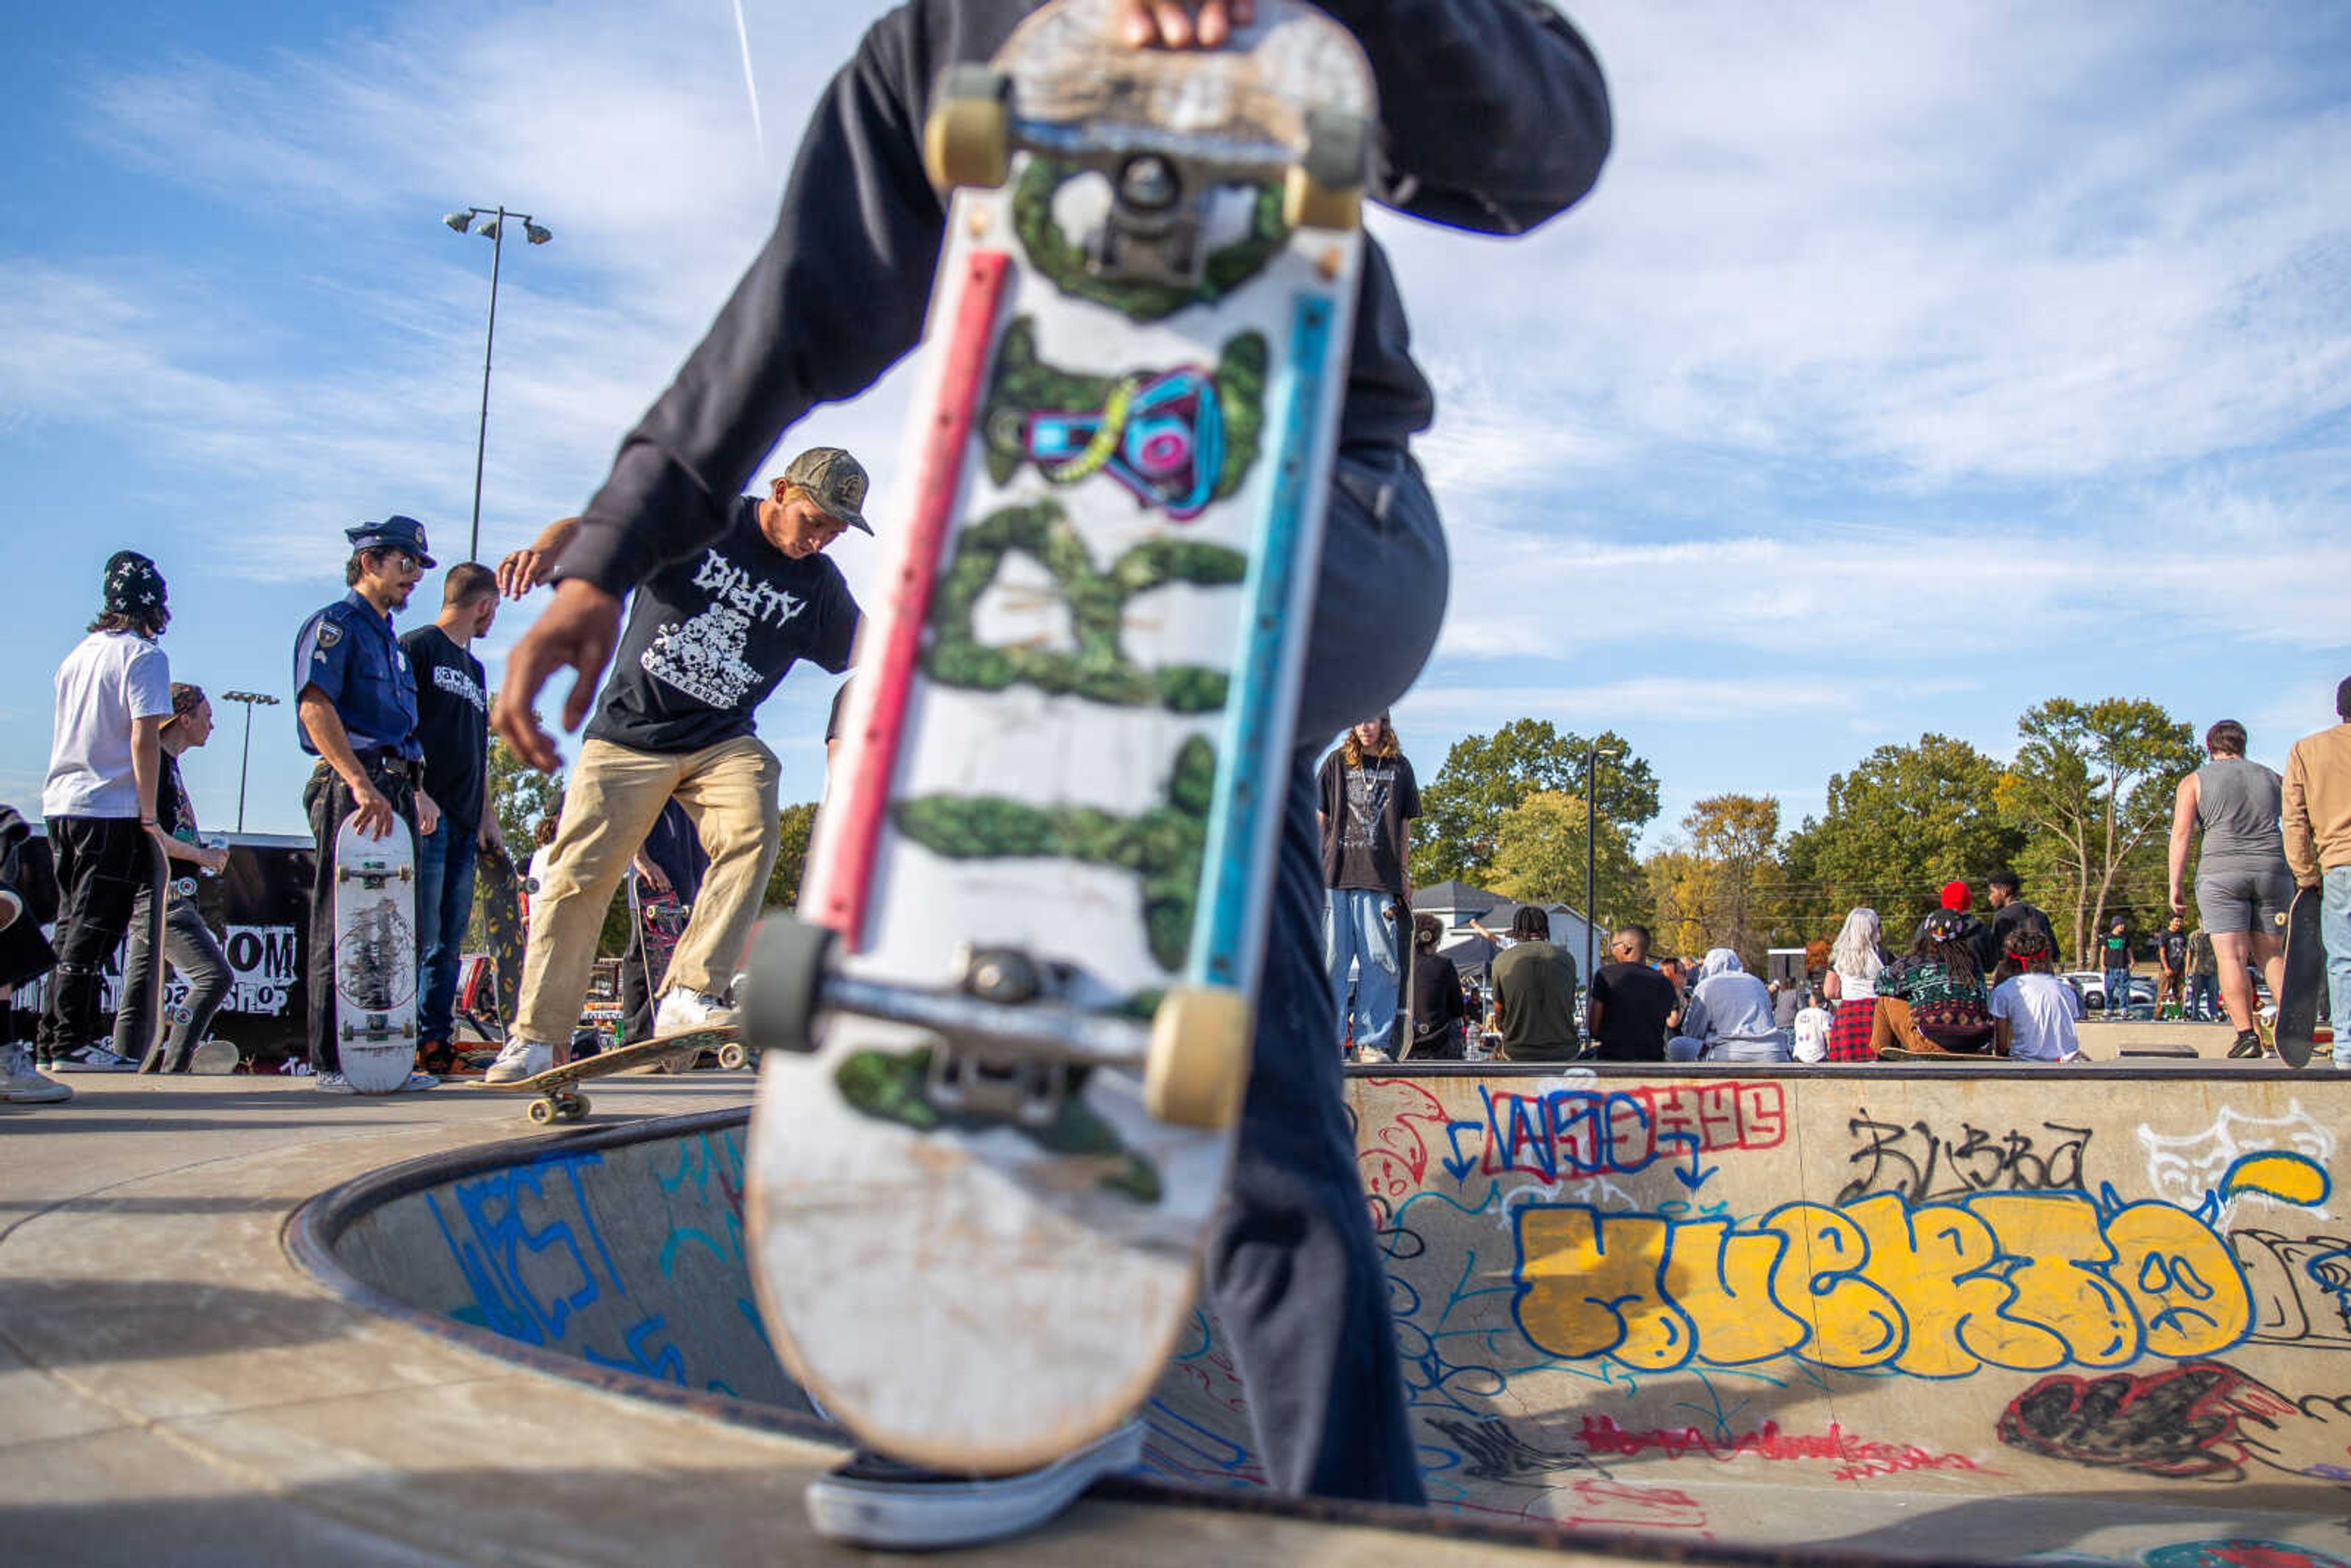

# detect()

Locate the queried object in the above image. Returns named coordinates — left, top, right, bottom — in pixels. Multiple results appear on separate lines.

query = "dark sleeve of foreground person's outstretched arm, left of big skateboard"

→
left=555, top=9, right=945, bottom=595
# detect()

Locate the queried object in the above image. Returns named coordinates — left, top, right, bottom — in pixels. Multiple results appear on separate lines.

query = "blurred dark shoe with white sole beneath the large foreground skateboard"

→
left=809, top=1420, right=1142, bottom=1549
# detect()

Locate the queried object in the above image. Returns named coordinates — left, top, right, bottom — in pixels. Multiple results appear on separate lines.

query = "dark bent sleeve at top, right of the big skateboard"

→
left=1321, top=0, right=1610, bottom=235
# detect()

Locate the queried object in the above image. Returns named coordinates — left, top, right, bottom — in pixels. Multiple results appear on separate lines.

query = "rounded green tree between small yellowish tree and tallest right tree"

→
left=1785, top=733, right=2027, bottom=931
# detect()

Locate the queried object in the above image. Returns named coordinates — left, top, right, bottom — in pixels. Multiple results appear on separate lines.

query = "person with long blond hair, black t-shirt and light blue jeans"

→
left=1316, top=712, right=1420, bottom=1060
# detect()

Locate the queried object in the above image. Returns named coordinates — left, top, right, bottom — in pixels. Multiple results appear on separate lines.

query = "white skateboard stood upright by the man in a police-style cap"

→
left=334, top=818, right=416, bottom=1095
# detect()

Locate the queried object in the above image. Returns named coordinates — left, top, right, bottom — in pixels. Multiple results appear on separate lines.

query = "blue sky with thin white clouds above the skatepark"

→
left=0, top=0, right=2351, bottom=844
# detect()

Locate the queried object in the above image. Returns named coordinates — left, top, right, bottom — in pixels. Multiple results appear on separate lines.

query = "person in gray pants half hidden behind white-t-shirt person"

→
left=115, top=681, right=233, bottom=1072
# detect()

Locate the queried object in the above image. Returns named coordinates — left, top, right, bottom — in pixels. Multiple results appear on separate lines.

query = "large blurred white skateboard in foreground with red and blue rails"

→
left=745, top=0, right=1375, bottom=1474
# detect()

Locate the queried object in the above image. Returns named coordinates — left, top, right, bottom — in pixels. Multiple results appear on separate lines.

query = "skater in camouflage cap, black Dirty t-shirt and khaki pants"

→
left=487, top=447, right=872, bottom=1084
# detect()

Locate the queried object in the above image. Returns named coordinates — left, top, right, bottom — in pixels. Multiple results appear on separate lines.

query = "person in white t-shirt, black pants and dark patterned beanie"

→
left=34, top=550, right=171, bottom=1072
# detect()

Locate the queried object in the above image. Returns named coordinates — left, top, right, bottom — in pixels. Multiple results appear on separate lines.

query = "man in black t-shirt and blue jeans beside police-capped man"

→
left=400, top=562, right=506, bottom=1072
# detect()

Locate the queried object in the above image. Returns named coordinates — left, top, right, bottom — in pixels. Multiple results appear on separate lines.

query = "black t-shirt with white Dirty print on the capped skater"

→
left=588, top=496, right=858, bottom=755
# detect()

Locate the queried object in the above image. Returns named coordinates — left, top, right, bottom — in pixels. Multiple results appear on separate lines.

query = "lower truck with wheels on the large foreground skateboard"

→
left=743, top=915, right=1251, bottom=1126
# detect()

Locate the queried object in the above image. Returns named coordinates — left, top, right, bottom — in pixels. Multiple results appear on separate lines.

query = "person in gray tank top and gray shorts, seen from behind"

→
left=2172, top=719, right=2295, bottom=1056
